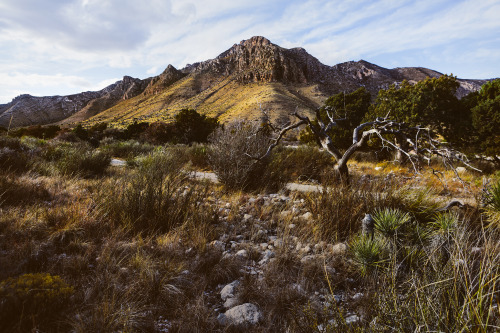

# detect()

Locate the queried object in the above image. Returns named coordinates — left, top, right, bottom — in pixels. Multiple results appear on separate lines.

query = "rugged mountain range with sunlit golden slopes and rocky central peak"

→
left=0, top=36, right=486, bottom=127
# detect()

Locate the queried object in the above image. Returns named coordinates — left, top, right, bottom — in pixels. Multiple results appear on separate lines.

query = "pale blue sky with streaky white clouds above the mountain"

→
left=0, top=0, right=500, bottom=104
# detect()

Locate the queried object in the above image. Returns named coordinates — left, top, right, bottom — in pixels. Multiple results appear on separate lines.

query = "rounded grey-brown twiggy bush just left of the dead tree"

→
left=208, top=122, right=285, bottom=191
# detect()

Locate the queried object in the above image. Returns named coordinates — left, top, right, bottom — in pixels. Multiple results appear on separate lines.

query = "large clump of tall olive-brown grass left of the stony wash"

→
left=97, top=150, right=213, bottom=234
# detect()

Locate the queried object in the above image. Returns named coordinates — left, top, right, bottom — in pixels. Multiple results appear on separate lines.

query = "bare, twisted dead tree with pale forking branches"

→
left=248, top=109, right=480, bottom=183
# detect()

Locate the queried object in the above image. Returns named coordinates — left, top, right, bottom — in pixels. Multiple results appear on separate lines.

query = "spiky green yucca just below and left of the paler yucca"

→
left=348, top=235, right=388, bottom=276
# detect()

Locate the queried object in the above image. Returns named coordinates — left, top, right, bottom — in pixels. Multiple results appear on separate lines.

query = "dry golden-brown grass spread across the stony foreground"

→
left=0, top=134, right=500, bottom=332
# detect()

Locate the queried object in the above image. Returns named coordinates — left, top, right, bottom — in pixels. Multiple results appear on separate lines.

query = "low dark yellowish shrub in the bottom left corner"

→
left=0, top=273, right=74, bottom=331
